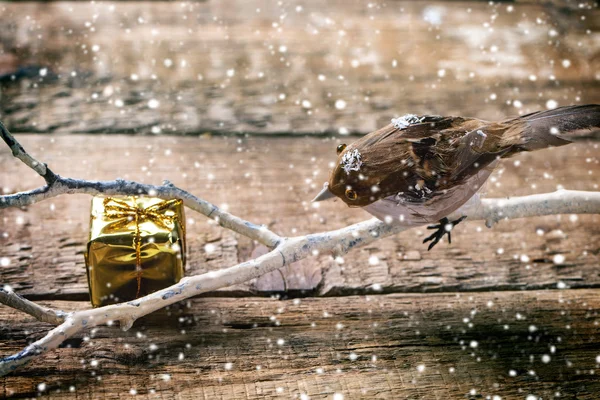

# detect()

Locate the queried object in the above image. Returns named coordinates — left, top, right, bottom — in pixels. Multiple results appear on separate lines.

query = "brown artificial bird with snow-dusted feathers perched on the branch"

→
left=313, top=104, right=600, bottom=250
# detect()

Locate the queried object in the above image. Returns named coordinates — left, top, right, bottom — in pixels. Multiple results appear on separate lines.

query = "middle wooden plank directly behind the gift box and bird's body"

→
left=0, top=135, right=600, bottom=300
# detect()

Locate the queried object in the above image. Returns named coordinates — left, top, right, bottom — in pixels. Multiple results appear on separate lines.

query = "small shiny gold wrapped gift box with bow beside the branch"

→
left=85, top=197, right=185, bottom=307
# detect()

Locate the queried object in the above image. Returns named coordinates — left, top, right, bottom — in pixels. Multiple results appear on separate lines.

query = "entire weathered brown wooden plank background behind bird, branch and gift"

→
left=0, top=0, right=600, bottom=399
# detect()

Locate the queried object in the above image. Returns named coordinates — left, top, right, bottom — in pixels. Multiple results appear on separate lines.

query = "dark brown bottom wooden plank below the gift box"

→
left=0, top=290, right=600, bottom=399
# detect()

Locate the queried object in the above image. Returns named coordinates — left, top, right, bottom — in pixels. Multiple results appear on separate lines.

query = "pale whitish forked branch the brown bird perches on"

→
left=0, top=125, right=600, bottom=376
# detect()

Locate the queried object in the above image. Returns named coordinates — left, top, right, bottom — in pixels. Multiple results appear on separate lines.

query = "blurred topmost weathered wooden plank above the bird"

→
left=0, top=0, right=600, bottom=134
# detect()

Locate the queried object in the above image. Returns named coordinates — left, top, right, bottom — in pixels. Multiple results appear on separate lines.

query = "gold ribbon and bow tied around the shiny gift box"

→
left=104, top=197, right=185, bottom=298
